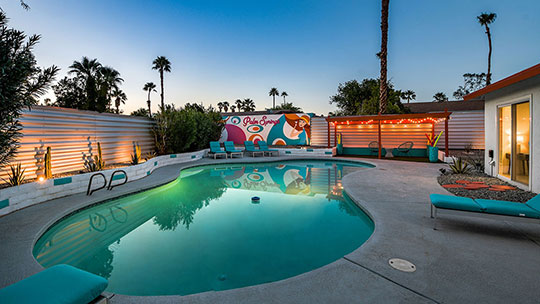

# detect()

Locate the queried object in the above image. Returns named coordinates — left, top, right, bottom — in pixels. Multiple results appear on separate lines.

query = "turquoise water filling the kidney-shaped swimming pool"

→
left=34, top=161, right=373, bottom=295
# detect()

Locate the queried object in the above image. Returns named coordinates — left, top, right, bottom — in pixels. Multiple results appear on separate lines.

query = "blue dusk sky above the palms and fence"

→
left=0, top=0, right=540, bottom=114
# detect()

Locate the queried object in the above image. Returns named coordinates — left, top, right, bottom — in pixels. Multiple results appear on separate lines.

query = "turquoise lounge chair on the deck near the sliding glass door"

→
left=429, top=194, right=540, bottom=229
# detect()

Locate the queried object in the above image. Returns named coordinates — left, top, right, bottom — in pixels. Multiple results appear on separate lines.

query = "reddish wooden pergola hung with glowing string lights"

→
left=326, top=110, right=452, bottom=158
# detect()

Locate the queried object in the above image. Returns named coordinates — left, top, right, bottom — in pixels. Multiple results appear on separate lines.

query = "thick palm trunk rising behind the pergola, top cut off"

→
left=378, top=0, right=390, bottom=114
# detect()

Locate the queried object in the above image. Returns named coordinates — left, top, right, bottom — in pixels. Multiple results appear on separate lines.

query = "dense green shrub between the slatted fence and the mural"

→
left=154, top=104, right=223, bottom=154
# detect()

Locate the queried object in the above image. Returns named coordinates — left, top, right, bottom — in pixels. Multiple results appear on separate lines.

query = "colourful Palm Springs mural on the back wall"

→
left=221, top=113, right=311, bottom=146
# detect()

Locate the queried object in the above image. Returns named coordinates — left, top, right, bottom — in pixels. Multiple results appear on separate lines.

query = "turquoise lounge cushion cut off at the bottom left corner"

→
left=0, top=265, right=109, bottom=303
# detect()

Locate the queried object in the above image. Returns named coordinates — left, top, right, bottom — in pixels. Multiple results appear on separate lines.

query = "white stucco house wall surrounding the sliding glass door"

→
left=484, top=75, right=540, bottom=193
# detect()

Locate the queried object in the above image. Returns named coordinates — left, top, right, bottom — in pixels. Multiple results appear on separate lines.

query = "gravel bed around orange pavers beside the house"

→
left=437, top=173, right=536, bottom=203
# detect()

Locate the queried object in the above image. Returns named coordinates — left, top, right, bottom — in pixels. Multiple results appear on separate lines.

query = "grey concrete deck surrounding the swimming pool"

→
left=0, top=157, right=540, bottom=303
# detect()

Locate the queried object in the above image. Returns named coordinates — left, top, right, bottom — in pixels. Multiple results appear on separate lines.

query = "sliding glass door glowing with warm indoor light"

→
left=499, top=102, right=530, bottom=185
